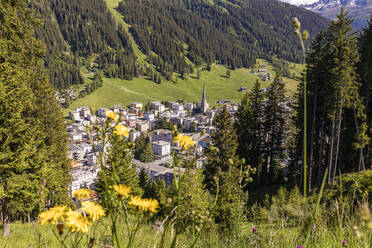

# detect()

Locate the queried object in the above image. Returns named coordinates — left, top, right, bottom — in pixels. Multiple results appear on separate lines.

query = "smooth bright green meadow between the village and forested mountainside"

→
left=65, top=62, right=298, bottom=112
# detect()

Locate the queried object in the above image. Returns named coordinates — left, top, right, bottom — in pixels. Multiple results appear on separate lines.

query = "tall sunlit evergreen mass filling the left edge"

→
left=0, top=1, right=69, bottom=235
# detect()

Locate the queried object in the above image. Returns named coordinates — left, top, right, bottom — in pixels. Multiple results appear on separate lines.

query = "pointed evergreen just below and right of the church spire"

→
left=204, top=106, right=245, bottom=228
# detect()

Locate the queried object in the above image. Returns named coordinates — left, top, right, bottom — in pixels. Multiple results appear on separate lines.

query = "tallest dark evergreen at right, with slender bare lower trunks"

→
left=292, top=9, right=369, bottom=189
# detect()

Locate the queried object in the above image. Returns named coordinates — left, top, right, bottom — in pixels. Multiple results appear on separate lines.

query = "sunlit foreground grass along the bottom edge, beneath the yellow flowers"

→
left=0, top=219, right=371, bottom=248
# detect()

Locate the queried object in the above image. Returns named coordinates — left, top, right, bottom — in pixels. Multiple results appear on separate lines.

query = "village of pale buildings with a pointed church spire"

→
left=67, top=85, right=238, bottom=194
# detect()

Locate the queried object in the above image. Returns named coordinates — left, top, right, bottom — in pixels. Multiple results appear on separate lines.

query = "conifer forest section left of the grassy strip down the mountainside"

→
left=32, top=0, right=135, bottom=88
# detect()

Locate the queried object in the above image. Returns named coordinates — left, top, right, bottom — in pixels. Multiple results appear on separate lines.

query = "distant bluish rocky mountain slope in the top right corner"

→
left=301, top=0, right=372, bottom=29
